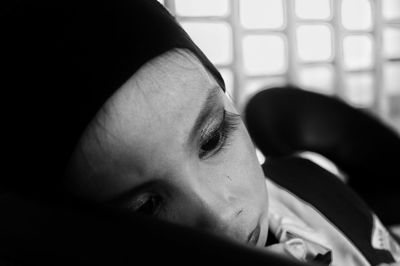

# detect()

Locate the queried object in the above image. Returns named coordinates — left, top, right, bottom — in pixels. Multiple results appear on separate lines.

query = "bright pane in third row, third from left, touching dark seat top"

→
left=299, top=66, right=334, bottom=94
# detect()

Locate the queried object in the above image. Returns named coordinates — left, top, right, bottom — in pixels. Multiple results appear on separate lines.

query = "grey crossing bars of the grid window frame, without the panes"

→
left=164, top=0, right=400, bottom=132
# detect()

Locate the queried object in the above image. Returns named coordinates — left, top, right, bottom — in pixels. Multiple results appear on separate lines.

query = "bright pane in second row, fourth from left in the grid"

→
left=343, top=36, right=373, bottom=70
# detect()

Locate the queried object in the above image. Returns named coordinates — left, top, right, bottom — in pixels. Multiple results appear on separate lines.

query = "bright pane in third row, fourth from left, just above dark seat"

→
left=345, top=74, right=374, bottom=107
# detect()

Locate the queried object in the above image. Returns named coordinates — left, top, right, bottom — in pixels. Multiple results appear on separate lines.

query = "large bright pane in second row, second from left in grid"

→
left=243, top=35, right=287, bottom=75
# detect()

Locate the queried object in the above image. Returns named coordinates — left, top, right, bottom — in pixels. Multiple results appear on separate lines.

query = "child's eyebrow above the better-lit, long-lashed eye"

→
left=187, top=86, right=220, bottom=143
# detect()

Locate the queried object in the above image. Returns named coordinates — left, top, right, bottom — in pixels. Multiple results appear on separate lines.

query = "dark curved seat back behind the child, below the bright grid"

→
left=245, top=86, right=400, bottom=225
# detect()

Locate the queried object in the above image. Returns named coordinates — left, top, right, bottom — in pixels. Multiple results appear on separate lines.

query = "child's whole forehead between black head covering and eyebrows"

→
left=70, top=50, right=222, bottom=200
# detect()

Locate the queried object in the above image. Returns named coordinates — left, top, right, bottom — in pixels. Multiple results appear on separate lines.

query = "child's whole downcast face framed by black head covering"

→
left=70, top=50, right=268, bottom=246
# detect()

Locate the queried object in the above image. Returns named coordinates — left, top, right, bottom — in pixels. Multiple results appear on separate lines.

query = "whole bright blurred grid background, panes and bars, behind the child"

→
left=159, top=0, right=400, bottom=133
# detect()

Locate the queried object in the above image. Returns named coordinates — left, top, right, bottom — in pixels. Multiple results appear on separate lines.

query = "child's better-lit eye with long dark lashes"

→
left=199, top=110, right=240, bottom=159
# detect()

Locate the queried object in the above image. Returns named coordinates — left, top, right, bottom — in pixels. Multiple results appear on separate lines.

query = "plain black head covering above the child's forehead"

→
left=0, top=0, right=224, bottom=202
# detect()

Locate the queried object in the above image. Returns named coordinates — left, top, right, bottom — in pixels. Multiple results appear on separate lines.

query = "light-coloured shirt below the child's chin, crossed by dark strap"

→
left=266, top=179, right=400, bottom=266
